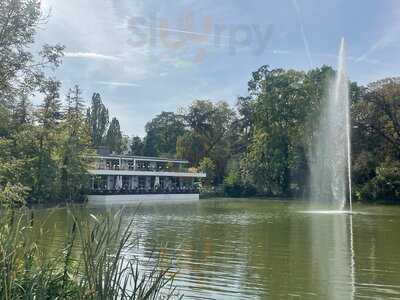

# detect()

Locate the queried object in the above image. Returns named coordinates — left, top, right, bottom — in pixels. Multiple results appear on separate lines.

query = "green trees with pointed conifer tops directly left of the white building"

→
left=0, top=82, right=93, bottom=203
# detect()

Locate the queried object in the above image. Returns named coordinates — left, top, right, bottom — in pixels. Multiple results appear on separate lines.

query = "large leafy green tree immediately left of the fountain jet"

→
left=238, top=66, right=353, bottom=196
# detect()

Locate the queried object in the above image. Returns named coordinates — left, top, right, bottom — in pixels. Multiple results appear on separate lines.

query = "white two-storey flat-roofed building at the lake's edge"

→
left=89, top=155, right=206, bottom=202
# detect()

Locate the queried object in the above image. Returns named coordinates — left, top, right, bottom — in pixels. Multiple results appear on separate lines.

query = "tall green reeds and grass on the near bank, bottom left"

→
left=0, top=211, right=178, bottom=300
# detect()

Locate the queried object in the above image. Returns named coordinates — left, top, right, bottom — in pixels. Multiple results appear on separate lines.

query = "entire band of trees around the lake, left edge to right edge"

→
left=0, top=0, right=400, bottom=205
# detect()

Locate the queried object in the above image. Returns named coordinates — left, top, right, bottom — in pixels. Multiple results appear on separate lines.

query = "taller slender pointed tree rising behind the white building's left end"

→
left=87, top=93, right=109, bottom=147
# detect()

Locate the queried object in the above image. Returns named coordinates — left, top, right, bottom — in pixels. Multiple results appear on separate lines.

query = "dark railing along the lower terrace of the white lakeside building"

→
left=90, top=187, right=199, bottom=195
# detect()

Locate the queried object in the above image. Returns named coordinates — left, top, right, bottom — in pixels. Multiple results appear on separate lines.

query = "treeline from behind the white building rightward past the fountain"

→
left=118, top=66, right=400, bottom=201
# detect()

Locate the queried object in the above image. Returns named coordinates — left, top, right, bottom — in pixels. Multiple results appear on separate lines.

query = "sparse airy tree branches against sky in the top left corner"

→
left=0, top=0, right=64, bottom=106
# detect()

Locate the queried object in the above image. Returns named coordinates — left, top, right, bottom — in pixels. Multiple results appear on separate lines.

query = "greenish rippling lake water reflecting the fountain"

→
left=35, top=199, right=400, bottom=299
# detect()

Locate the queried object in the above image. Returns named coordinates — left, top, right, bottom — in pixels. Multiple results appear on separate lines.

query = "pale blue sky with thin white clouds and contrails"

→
left=35, top=0, right=400, bottom=136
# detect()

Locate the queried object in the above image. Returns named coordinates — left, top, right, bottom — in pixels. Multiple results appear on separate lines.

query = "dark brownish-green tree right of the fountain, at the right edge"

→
left=352, top=78, right=400, bottom=200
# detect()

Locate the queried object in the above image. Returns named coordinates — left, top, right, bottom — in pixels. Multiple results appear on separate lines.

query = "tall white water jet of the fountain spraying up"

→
left=311, top=39, right=352, bottom=211
